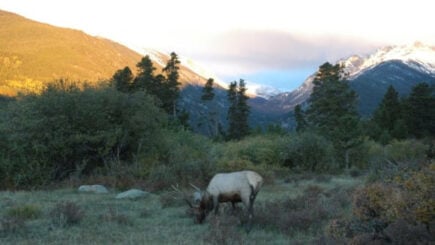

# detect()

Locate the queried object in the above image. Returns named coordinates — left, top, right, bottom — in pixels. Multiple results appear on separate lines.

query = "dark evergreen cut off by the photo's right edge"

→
left=405, top=83, right=435, bottom=138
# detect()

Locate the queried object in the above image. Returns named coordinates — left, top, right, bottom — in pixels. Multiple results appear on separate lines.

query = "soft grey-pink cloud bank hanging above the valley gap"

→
left=192, top=30, right=379, bottom=75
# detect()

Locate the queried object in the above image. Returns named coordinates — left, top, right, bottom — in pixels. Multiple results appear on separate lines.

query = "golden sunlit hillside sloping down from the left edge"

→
left=0, top=10, right=213, bottom=95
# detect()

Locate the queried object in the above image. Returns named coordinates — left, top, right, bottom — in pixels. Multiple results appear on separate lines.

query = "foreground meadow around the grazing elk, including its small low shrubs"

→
left=0, top=173, right=362, bottom=244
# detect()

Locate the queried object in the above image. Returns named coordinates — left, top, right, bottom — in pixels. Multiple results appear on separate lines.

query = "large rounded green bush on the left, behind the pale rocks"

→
left=0, top=81, right=165, bottom=186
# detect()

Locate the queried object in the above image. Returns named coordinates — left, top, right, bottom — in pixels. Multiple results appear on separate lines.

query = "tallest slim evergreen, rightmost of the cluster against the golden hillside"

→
left=162, top=52, right=180, bottom=118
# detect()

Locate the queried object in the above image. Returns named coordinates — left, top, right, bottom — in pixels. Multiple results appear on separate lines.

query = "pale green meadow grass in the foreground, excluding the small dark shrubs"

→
left=0, top=176, right=361, bottom=244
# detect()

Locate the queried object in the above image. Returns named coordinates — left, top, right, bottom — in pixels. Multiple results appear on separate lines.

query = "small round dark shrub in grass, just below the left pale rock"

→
left=50, top=202, right=84, bottom=227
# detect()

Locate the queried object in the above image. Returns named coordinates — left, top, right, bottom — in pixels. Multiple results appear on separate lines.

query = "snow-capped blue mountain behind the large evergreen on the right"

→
left=262, top=43, right=435, bottom=116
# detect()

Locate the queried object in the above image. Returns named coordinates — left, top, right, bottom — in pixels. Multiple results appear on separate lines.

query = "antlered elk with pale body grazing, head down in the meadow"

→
left=175, top=170, right=263, bottom=226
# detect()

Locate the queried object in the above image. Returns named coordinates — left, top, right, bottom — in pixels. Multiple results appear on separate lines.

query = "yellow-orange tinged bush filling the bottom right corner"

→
left=340, top=163, right=435, bottom=244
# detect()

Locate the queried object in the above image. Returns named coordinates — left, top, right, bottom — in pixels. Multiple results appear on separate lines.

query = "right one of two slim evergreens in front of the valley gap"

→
left=227, top=79, right=250, bottom=140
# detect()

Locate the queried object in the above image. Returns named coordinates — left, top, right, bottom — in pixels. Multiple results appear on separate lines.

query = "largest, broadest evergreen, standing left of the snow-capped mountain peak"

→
left=307, top=63, right=361, bottom=167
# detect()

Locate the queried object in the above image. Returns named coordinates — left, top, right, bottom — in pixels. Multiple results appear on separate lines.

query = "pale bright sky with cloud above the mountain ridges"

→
left=0, top=0, right=435, bottom=91
